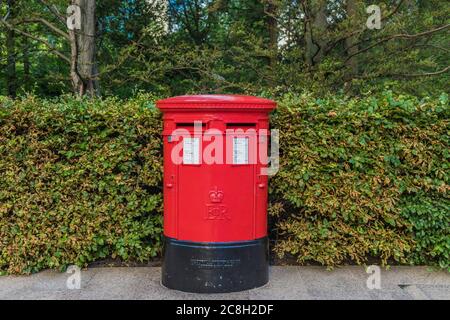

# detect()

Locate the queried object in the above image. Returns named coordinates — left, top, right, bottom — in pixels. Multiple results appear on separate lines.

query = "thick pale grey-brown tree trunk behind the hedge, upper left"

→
left=69, top=0, right=99, bottom=96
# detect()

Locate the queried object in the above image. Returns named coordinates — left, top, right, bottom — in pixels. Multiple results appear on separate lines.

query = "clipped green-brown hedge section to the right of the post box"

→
left=270, top=92, right=450, bottom=267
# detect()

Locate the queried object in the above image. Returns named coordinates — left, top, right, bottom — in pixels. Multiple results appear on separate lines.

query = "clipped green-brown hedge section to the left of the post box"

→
left=0, top=96, right=162, bottom=273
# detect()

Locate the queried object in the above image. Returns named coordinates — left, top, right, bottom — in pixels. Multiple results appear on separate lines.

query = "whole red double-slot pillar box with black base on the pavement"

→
left=157, top=95, right=276, bottom=293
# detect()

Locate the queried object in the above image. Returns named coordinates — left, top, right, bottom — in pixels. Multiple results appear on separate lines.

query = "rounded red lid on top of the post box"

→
left=156, top=94, right=276, bottom=111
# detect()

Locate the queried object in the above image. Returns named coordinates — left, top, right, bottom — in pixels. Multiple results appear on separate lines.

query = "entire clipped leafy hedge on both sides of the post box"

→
left=0, top=92, right=450, bottom=273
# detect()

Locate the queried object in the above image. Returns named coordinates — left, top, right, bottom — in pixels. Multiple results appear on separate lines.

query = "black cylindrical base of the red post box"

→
left=162, top=237, right=269, bottom=293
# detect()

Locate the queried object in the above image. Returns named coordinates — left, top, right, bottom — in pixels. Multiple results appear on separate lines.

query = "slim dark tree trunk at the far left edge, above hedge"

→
left=6, top=0, right=17, bottom=98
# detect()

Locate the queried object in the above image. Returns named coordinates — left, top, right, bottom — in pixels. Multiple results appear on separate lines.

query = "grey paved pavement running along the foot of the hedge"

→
left=0, top=266, right=450, bottom=300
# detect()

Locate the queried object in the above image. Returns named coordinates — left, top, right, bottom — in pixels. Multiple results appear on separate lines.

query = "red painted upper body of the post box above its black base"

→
left=157, top=95, right=276, bottom=242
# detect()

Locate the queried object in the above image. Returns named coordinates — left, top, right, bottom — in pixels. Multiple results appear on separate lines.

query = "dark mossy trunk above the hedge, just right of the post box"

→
left=304, top=0, right=327, bottom=66
